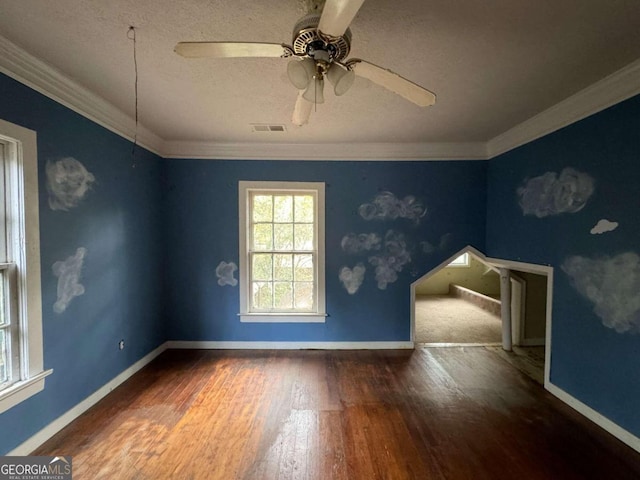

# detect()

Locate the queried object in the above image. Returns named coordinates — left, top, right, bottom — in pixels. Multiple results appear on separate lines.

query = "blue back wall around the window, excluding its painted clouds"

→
left=165, top=160, right=487, bottom=342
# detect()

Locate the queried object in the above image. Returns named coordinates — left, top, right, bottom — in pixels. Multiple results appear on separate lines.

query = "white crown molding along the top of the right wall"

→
left=487, top=59, right=640, bottom=159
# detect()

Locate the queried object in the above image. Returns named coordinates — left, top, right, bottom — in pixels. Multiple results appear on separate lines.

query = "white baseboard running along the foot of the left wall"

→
left=7, top=343, right=167, bottom=456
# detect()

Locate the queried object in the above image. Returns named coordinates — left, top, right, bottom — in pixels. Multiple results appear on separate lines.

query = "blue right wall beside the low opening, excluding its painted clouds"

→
left=486, top=96, right=640, bottom=436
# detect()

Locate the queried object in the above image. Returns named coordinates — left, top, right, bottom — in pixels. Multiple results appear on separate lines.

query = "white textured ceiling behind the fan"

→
left=0, top=0, right=640, bottom=158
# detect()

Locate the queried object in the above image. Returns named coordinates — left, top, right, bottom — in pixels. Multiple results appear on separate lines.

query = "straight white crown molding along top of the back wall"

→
left=163, top=142, right=487, bottom=161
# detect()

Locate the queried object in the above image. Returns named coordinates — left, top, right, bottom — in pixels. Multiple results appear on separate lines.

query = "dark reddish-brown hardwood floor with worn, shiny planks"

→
left=34, top=347, right=640, bottom=480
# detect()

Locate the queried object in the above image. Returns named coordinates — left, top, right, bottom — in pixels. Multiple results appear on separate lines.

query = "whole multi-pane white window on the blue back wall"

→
left=239, top=182, right=325, bottom=322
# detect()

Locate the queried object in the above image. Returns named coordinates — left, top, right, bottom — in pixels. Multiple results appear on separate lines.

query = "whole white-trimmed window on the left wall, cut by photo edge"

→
left=0, top=120, right=52, bottom=413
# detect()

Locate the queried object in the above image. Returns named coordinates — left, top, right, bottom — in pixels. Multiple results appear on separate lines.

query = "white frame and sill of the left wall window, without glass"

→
left=0, top=120, right=53, bottom=413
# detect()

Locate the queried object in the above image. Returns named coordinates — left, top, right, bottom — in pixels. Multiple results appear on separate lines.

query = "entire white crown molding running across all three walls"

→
left=0, top=36, right=640, bottom=161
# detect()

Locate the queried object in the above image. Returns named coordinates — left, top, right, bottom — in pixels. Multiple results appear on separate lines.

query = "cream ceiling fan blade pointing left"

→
left=174, top=42, right=288, bottom=58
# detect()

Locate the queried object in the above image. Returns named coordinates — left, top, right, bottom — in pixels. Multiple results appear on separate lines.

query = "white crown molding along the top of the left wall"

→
left=0, top=36, right=163, bottom=155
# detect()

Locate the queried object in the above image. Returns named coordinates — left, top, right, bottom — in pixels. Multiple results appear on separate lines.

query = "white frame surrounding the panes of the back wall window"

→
left=238, top=181, right=327, bottom=323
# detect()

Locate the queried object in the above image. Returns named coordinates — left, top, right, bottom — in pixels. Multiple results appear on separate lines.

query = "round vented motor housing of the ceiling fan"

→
left=292, top=13, right=351, bottom=62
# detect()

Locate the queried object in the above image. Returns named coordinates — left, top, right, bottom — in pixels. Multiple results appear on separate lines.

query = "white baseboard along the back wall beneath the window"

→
left=167, top=341, right=414, bottom=350
